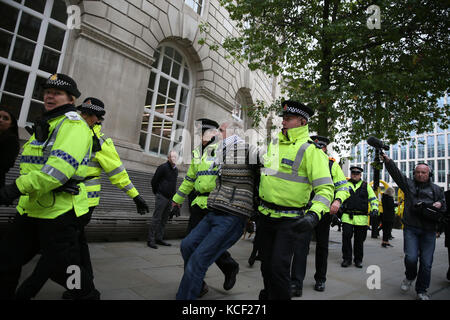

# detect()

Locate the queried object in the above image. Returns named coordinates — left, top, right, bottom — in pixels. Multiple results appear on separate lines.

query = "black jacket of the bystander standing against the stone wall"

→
left=152, top=161, right=178, bottom=199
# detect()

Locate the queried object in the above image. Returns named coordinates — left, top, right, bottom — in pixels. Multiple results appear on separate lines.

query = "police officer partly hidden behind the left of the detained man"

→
left=172, top=118, right=239, bottom=297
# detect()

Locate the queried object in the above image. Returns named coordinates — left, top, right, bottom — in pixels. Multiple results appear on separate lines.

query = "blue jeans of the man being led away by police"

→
left=177, top=212, right=247, bottom=300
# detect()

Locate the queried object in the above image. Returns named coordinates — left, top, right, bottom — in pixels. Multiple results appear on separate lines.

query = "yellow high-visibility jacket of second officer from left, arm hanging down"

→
left=85, top=125, right=139, bottom=207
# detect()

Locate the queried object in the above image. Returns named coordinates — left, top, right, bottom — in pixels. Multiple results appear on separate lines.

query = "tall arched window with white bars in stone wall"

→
left=139, top=46, right=192, bottom=156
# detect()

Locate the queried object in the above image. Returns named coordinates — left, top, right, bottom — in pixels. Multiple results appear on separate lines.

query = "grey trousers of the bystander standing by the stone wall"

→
left=147, top=193, right=172, bottom=243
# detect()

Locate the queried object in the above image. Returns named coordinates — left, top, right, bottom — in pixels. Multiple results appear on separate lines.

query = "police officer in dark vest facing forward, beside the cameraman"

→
left=341, top=166, right=378, bottom=268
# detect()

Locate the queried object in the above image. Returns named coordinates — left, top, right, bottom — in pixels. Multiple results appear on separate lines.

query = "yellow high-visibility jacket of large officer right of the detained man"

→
left=258, top=125, right=334, bottom=219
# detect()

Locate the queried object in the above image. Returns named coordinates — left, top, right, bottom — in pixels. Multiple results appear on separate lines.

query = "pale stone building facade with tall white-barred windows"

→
left=0, top=0, right=279, bottom=232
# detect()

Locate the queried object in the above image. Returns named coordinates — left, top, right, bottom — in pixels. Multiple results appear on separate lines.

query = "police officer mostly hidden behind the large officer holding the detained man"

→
left=291, top=136, right=350, bottom=297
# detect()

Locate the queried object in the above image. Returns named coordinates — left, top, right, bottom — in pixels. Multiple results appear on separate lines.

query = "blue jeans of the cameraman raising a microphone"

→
left=403, top=226, right=436, bottom=293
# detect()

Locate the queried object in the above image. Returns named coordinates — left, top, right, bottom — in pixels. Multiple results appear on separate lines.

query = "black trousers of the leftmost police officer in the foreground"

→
left=0, top=210, right=94, bottom=299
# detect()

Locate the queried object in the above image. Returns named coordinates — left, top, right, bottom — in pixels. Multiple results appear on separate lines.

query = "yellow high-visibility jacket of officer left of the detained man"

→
left=172, top=143, right=218, bottom=209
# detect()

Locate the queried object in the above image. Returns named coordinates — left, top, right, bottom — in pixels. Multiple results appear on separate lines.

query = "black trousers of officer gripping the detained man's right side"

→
left=258, top=214, right=299, bottom=300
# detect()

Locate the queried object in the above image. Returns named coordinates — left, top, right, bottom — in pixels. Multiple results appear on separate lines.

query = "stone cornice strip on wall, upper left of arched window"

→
left=76, top=23, right=153, bottom=68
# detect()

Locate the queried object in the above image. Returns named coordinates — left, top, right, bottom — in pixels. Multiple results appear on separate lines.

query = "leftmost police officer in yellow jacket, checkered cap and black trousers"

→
left=0, top=73, right=93, bottom=299
